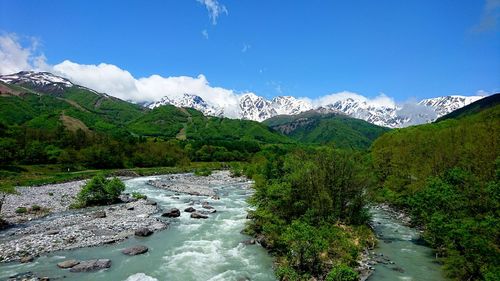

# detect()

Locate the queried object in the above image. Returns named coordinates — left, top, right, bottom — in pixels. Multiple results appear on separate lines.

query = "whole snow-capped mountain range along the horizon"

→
left=0, top=71, right=483, bottom=128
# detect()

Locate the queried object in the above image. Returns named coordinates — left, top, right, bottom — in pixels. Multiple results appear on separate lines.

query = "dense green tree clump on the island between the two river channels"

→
left=245, top=147, right=376, bottom=280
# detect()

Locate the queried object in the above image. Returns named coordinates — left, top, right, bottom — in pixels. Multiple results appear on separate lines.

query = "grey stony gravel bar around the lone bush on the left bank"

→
left=0, top=178, right=167, bottom=262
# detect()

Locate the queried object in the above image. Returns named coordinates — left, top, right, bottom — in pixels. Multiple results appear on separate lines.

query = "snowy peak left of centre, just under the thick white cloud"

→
left=146, top=93, right=224, bottom=116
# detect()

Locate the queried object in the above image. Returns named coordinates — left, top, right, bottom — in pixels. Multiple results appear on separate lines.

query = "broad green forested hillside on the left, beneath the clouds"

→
left=0, top=79, right=293, bottom=170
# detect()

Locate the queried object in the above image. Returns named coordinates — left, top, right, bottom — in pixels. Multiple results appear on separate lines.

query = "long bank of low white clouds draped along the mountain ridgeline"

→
left=0, top=34, right=476, bottom=118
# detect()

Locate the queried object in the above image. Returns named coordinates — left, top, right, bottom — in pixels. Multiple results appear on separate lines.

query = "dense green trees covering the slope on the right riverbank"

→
left=372, top=104, right=500, bottom=280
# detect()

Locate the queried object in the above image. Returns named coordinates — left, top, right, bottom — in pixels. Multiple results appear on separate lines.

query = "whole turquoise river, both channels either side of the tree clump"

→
left=0, top=174, right=445, bottom=281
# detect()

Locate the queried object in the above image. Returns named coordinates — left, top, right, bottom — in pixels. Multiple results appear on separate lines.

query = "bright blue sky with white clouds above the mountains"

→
left=0, top=0, right=500, bottom=108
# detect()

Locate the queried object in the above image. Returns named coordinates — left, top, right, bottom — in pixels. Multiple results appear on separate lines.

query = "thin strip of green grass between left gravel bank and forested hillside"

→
left=0, top=162, right=234, bottom=186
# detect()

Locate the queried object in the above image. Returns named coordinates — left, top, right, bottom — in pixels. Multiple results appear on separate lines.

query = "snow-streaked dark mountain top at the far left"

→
left=0, top=71, right=74, bottom=94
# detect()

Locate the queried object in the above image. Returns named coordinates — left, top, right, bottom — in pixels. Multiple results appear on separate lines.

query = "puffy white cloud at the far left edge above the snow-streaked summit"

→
left=0, top=33, right=46, bottom=74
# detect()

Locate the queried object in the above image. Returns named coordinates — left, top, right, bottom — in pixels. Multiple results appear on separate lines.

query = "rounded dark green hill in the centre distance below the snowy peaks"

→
left=263, top=111, right=389, bottom=148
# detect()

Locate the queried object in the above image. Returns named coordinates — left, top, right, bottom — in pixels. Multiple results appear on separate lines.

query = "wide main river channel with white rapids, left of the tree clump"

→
left=0, top=174, right=275, bottom=281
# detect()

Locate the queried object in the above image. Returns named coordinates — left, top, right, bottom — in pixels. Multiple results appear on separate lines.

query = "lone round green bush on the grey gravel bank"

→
left=73, top=175, right=125, bottom=208
